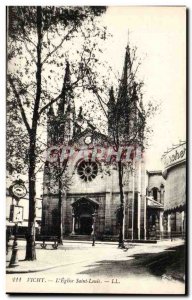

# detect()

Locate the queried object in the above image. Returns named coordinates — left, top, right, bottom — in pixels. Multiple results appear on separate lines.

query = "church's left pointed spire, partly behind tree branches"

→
left=58, top=61, right=74, bottom=115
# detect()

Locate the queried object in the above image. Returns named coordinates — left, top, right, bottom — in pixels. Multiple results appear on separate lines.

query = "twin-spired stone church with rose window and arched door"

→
left=41, top=47, right=147, bottom=240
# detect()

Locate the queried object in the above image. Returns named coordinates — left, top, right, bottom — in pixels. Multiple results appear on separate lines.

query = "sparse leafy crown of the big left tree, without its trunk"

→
left=7, top=6, right=106, bottom=176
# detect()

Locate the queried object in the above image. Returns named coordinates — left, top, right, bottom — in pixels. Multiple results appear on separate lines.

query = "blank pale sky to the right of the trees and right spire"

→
left=102, top=6, right=186, bottom=170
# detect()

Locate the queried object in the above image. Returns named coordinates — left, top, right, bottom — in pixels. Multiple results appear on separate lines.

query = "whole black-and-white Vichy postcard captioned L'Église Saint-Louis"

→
left=6, top=6, right=187, bottom=295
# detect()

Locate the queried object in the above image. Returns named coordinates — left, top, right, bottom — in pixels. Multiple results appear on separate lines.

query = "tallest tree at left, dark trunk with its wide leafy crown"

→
left=7, top=6, right=106, bottom=260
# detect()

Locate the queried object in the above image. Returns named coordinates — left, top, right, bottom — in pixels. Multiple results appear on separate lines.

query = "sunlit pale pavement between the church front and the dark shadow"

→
left=6, top=240, right=183, bottom=274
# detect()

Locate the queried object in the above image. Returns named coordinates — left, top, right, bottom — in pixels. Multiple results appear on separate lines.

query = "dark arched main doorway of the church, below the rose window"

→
left=72, top=198, right=99, bottom=235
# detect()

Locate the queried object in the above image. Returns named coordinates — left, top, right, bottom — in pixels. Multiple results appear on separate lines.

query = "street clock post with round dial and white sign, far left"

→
left=9, top=180, right=27, bottom=268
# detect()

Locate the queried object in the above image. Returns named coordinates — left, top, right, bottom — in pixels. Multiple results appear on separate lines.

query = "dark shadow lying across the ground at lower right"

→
left=79, top=245, right=185, bottom=282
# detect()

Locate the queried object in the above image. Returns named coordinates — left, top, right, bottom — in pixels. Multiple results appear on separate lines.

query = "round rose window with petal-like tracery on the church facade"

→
left=77, top=161, right=98, bottom=181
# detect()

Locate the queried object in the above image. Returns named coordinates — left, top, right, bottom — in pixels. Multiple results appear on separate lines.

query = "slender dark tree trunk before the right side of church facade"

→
left=118, top=161, right=125, bottom=248
